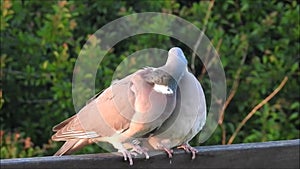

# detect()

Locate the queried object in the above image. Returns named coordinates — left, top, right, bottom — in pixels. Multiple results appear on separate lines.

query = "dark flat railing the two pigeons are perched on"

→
left=1, top=139, right=300, bottom=169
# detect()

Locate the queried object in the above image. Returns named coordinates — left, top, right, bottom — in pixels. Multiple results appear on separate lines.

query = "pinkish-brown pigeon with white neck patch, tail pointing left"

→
left=52, top=47, right=187, bottom=165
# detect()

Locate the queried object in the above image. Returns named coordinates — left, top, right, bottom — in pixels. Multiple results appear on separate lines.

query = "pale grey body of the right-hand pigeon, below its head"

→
left=129, top=49, right=206, bottom=159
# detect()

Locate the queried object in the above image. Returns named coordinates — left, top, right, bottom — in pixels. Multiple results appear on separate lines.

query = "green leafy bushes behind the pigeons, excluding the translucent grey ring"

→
left=0, top=0, right=300, bottom=158
